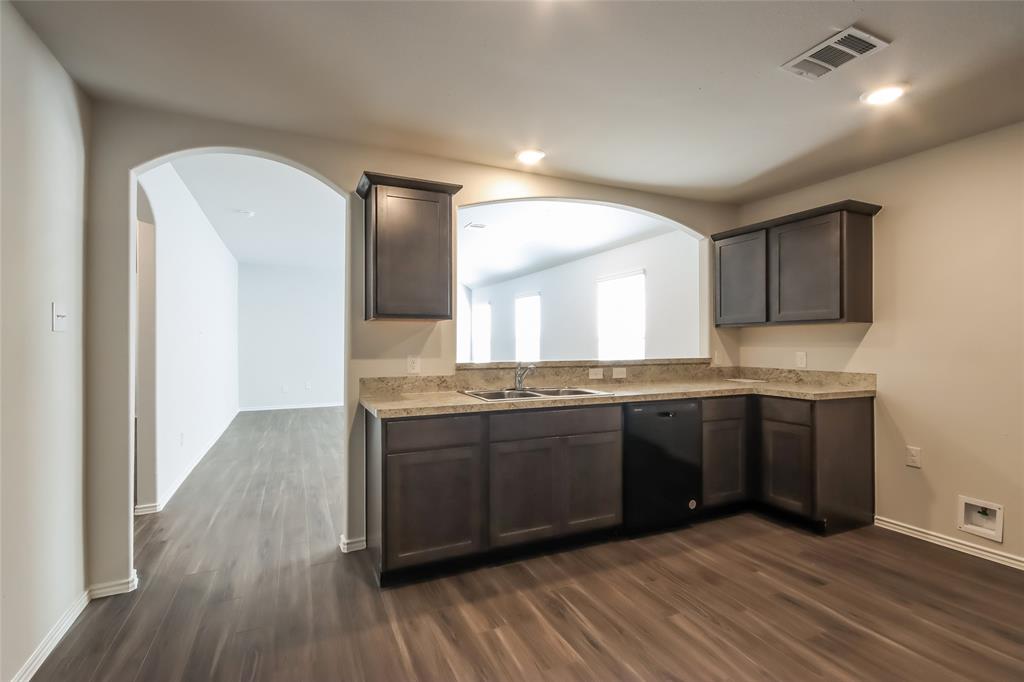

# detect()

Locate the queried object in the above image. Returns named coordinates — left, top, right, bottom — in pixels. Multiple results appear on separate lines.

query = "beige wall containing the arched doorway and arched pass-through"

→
left=86, top=102, right=736, bottom=583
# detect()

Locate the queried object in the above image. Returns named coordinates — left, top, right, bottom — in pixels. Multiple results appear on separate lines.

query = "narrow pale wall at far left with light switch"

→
left=0, top=2, right=88, bottom=680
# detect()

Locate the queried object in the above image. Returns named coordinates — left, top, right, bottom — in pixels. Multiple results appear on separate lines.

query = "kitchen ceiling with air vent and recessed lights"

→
left=17, top=1, right=1024, bottom=202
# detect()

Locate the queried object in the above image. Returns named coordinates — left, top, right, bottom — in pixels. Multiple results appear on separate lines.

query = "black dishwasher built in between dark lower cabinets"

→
left=623, top=400, right=701, bottom=530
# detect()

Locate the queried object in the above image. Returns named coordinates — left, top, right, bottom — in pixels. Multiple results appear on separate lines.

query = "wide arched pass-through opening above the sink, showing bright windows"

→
left=457, top=198, right=707, bottom=363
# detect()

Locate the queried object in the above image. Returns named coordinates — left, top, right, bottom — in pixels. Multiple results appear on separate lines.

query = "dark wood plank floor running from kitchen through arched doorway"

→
left=35, top=410, right=1024, bottom=682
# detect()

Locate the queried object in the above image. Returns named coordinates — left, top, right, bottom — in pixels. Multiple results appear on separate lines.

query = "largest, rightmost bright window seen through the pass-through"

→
left=597, top=270, right=647, bottom=359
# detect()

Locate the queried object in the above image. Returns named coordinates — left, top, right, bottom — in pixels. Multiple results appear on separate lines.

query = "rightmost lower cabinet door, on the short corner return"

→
left=761, top=420, right=813, bottom=516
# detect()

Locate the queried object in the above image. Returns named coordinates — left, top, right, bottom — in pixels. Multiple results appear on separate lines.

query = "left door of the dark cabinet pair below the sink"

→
left=487, top=438, right=564, bottom=547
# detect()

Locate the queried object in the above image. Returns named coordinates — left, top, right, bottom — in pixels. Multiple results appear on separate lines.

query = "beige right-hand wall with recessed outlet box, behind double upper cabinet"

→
left=739, top=124, right=1024, bottom=556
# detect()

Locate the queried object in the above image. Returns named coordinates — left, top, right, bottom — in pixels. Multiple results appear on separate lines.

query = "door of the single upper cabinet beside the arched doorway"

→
left=368, top=185, right=452, bottom=319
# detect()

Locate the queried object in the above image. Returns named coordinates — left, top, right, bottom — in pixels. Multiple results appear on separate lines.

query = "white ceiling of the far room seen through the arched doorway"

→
left=171, top=154, right=346, bottom=268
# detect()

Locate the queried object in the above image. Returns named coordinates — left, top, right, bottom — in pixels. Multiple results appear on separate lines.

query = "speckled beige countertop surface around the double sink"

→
left=359, top=379, right=874, bottom=419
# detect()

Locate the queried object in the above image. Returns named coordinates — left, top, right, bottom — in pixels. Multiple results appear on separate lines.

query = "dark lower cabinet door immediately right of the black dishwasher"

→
left=701, top=419, right=746, bottom=507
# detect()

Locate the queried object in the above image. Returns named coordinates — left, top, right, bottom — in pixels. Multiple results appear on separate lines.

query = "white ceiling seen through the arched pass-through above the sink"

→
left=458, top=200, right=681, bottom=289
